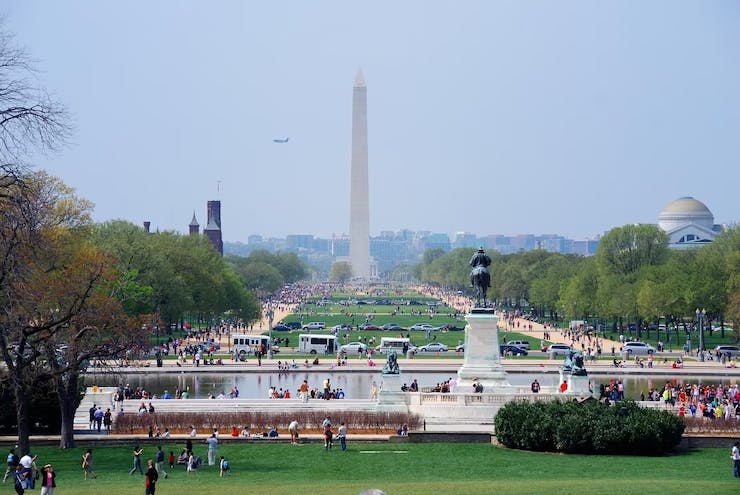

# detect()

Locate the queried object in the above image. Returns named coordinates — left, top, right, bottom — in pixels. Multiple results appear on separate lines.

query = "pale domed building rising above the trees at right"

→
left=658, top=196, right=722, bottom=249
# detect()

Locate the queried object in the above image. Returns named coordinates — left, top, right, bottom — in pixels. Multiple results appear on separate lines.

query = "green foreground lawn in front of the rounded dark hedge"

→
left=27, top=438, right=740, bottom=495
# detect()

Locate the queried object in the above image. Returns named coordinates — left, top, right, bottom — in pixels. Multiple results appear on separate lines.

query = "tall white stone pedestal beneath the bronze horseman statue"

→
left=457, top=314, right=510, bottom=392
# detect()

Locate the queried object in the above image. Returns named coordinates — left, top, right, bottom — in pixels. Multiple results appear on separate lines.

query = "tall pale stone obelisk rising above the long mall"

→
left=349, top=70, right=370, bottom=280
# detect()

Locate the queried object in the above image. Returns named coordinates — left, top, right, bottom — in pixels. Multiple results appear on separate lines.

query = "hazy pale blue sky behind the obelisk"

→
left=0, top=0, right=740, bottom=241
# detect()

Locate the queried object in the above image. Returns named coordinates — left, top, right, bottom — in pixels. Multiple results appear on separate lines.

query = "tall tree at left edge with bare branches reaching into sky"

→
left=0, top=25, right=70, bottom=451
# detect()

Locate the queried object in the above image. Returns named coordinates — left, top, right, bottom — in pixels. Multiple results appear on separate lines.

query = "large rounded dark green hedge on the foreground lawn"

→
left=494, top=401, right=685, bottom=455
